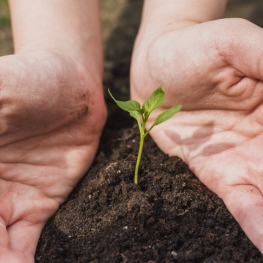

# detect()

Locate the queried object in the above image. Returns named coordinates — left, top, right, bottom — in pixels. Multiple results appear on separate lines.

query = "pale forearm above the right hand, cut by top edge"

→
left=138, top=0, right=227, bottom=41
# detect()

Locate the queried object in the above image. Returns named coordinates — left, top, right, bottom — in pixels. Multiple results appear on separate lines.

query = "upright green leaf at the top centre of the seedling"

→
left=142, top=85, right=165, bottom=115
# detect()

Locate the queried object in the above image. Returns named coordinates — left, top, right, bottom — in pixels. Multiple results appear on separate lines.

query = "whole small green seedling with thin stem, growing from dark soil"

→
left=108, top=85, right=182, bottom=184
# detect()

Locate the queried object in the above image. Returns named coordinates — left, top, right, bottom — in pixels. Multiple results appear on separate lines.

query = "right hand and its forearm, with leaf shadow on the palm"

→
left=131, top=0, right=263, bottom=253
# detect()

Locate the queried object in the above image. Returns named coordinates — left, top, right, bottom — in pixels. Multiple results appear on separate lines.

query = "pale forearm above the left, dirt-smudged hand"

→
left=9, top=0, right=102, bottom=71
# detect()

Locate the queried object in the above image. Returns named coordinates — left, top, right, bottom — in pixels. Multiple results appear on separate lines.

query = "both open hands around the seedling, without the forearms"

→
left=0, top=19, right=263, bottom=263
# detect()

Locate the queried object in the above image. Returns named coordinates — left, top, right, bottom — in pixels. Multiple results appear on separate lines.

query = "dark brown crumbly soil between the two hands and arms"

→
left=35, top=0, right=263, bottom=263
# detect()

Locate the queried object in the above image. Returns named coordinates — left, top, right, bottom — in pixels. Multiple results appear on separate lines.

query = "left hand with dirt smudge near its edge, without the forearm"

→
left=0, top=51, right=106, bottom=263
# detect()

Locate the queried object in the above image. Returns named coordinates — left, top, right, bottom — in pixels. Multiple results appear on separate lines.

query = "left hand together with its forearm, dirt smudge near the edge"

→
left=0, top=0, right=106, bottom=263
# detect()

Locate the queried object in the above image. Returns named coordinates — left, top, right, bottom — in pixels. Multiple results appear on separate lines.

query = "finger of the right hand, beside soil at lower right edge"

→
left=223, top=185, right=263, bottom=254
